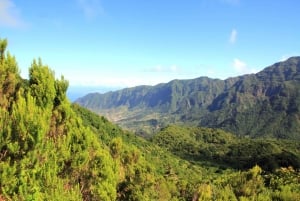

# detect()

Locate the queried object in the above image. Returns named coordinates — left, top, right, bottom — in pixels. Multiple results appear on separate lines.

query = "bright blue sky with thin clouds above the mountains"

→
left=0, top=0, right=300, bottom=87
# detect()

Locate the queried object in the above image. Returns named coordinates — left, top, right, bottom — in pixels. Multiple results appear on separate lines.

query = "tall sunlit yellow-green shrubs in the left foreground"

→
left=0, top=41, right=118, bottom=200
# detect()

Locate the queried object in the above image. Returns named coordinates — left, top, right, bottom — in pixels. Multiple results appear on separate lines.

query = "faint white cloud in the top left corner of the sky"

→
left=0, top=0, right=24, bottom=27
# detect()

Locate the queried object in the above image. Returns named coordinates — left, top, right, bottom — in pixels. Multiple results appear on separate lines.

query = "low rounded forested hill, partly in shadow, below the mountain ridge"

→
left=152, top=125, right=300, bottom=172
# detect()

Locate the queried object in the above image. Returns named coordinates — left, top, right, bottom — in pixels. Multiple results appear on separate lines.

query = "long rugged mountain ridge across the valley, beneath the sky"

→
left=76, top=57, right=300, bottom=139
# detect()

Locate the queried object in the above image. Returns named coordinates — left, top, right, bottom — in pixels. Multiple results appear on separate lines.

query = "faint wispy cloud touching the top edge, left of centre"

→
left=77, top=0, right=104, bottom=19
